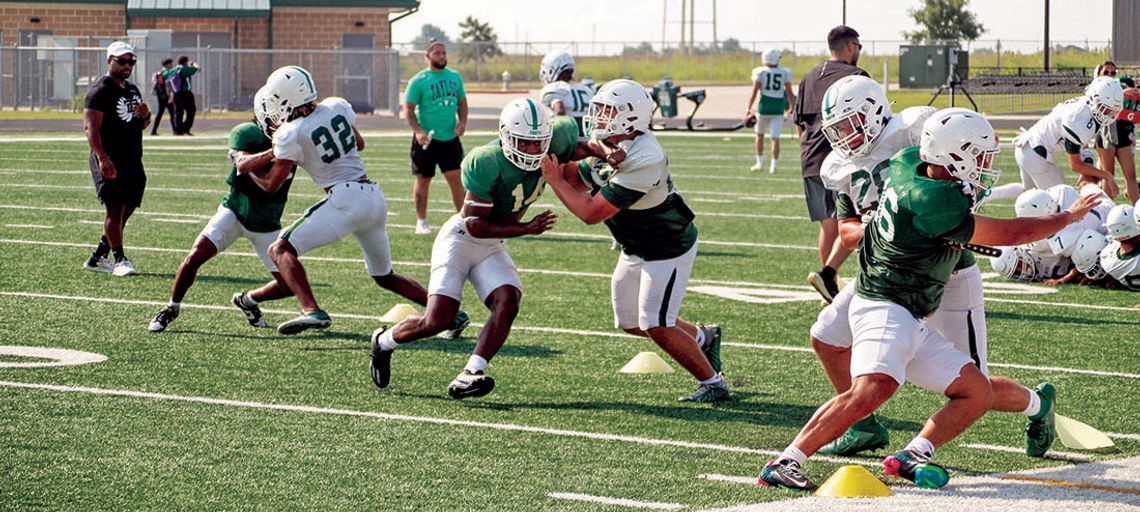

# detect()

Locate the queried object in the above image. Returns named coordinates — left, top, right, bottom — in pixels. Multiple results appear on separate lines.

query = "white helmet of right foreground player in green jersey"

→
left=919, top=108, right=1001, bottom=193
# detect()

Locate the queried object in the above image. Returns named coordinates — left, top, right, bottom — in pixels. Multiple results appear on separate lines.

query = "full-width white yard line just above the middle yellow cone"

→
left=0, top=289, right=1140, bottom=380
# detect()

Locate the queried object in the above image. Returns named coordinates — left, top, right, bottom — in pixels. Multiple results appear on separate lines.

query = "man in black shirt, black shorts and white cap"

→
left=83, top=42, right=150, bottom=276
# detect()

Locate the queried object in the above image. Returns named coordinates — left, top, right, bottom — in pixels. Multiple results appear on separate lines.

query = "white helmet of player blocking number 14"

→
left=583, top=79, right=653, bottom=140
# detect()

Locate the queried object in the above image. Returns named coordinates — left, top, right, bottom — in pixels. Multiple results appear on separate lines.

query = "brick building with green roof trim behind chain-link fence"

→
left=0, top=0, right=420, bottom=109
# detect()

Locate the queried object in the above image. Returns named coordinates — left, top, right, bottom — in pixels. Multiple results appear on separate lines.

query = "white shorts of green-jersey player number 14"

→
left=428, top=214, right=522, bottom=303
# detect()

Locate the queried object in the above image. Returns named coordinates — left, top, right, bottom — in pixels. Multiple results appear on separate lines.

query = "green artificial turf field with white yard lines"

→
left=0, top=127, right=1140, bottom=510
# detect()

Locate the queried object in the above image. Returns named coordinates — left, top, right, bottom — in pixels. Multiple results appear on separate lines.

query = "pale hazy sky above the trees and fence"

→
left=392, top=0, right=1112, bottom=49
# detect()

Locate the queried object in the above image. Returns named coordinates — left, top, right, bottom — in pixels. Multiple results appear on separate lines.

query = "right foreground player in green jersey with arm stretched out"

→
left=759, top=108, right=1096, bottom=490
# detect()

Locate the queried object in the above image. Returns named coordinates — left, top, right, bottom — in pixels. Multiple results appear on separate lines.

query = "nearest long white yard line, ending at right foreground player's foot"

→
left=0, top=381, right=878, bottom=465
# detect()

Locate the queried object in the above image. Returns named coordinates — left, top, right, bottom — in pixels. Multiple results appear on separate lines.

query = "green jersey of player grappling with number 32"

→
left=221, top=123, right=296, bottom=233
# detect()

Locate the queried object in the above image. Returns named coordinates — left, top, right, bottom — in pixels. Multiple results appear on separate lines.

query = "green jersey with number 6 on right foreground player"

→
left=855, top=146, right=974, bottom=318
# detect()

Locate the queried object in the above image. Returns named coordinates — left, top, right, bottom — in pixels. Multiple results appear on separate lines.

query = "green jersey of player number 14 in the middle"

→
left=459, top=116, right=578, bottom=219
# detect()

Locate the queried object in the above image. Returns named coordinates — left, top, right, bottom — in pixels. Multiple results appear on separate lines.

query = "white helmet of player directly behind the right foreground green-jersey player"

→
left=821, top=75, right=890, bottom=159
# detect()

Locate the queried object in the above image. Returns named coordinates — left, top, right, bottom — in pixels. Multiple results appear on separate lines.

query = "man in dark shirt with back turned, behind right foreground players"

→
left=792, top=25, right=868, bottom=302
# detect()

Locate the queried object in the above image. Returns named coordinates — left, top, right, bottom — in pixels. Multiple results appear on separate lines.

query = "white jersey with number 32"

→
left=274, top=98, right=365, bottom=188
